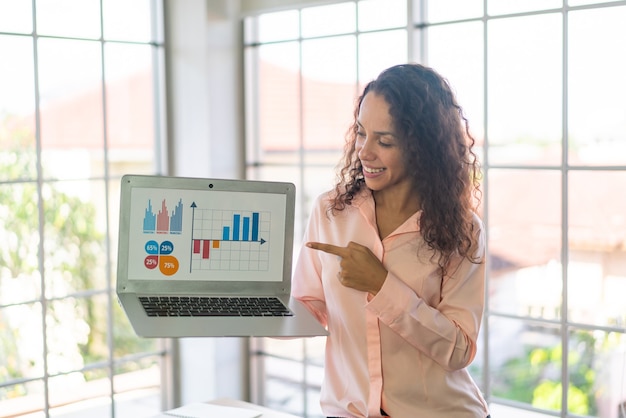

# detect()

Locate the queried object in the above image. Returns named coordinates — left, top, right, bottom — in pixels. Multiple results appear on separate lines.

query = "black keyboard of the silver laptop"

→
left=139, top=296, right=293, bottom=316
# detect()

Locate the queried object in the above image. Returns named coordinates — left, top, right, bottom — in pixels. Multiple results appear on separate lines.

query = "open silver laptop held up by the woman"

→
left=116, top=175, right=327, bottom=337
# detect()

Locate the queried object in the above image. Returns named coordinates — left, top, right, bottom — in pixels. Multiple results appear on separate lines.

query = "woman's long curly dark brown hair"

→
left=330, top=64, right=481, bottom=275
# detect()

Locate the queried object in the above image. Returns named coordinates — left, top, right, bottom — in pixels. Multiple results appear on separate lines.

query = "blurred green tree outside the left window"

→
left=0, top=117, right=154, bottom=399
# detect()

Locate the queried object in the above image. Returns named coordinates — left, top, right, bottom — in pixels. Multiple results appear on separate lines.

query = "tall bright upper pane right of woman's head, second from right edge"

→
left=487, top=14, right=562, bottom=165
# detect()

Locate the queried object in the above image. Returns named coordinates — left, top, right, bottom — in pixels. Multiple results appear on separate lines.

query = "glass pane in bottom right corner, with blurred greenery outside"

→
left=568, top=329, right=626, bottom=418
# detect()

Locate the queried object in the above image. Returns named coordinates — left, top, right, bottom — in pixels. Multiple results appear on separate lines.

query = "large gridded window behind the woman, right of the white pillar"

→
left=244, top=0, right=626, bottom=417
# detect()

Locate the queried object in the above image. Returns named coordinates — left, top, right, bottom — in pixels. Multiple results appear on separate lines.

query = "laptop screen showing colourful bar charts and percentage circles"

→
left=127, top=187, right=287, bottom=282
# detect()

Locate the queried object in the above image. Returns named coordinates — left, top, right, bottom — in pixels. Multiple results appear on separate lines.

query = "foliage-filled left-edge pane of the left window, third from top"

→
left=0, top=183, right=41, bottom=305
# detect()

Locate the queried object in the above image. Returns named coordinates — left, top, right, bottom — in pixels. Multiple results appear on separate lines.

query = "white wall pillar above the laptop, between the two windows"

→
left=164, top=0, right=244, bottom=178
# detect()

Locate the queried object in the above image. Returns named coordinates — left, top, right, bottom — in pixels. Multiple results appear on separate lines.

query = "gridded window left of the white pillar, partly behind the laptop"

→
left=0, top=0, right=168, bottom=417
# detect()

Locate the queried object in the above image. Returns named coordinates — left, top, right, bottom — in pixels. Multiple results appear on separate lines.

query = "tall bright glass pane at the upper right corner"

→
left=568, top=7, right=626, bottom=165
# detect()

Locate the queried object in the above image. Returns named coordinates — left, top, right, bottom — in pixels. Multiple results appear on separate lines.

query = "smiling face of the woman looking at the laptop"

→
left=355, top=92, right=411, bottom=197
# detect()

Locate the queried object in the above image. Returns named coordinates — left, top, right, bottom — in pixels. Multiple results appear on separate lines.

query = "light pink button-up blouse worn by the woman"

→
left=292, top=191, right=488, bottom=418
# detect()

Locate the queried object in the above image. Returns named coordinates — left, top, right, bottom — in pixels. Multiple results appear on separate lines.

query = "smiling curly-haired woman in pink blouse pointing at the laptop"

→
left=293, top=64, right=488, bottom=418
